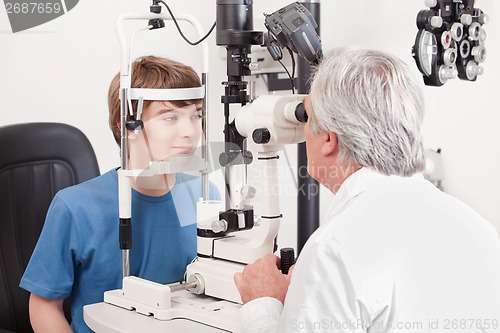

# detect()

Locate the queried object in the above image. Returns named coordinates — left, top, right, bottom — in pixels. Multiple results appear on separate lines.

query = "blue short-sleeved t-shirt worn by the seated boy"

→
left=20, top=169, right=220, bottom=333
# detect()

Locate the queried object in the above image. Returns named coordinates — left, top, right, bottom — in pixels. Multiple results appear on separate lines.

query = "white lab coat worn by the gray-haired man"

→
left=241, top=168, right=500, bottom=333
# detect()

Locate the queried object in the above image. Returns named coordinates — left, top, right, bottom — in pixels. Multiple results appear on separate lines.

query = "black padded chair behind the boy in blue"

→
left=0, top=123, right=99, bottom=333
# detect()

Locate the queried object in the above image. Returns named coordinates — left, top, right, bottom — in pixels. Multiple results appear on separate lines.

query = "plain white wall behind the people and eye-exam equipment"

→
left=0, top=0, right=500, bottom=252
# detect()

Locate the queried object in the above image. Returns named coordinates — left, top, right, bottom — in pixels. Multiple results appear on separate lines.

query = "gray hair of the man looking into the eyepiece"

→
left=310, top=47, right=425, bottom=176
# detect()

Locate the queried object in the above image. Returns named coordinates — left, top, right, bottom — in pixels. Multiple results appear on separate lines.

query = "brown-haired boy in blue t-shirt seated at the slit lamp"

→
left=20, top=56, right=219, bottom=333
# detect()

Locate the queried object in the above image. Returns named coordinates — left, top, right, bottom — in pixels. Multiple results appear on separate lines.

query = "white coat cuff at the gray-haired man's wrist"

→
left=240, top=297, right=283, bottom=333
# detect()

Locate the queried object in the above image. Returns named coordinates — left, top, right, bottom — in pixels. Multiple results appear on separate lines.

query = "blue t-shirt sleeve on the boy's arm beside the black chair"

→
left=20, top=192, right=78, bottom=299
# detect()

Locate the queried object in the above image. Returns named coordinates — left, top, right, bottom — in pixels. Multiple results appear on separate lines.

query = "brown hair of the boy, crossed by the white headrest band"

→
left=108, top=56, right=202, bottom=145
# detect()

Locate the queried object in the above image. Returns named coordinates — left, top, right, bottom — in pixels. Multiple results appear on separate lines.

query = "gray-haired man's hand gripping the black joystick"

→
left=234, top=254, right=295, bottom=304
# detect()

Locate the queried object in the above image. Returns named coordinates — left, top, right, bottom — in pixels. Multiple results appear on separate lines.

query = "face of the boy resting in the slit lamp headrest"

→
left=129, top=101, right=202, bottom=168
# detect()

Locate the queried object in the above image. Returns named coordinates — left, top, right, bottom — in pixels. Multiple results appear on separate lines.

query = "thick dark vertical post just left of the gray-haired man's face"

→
left=297, top=0, right=320, bottom=255
